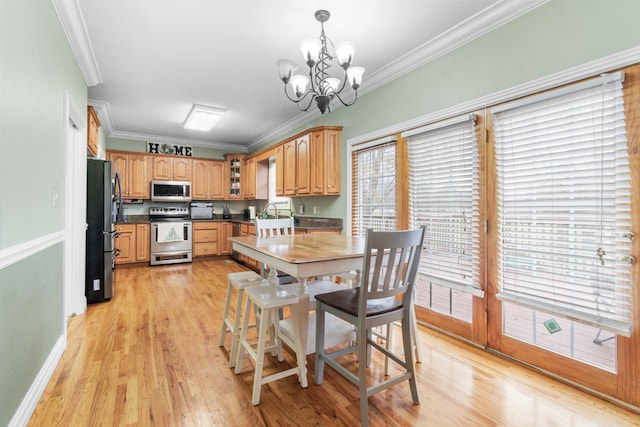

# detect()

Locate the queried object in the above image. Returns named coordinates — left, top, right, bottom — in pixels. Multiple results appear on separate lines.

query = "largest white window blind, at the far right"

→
left=493, top=73, right=632, bottom=336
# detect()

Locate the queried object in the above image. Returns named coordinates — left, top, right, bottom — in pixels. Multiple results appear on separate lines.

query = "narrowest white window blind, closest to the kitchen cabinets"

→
left=351, top=138, right=397, bottom=236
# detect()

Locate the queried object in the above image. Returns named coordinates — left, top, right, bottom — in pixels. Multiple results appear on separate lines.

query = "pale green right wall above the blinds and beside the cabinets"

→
left=252, top=0, right=640, bottom=220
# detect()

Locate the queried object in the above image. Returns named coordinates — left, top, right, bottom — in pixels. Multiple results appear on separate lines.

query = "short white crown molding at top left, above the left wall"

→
left=51, top=0, right=102, bottom=87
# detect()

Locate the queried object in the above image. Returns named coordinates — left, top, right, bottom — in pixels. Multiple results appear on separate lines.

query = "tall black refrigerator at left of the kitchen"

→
left=85, top=159, right=121, bottom=303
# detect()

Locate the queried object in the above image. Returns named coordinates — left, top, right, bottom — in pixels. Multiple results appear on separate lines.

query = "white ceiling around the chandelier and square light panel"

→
left=66, top=0, right=544, bottom=150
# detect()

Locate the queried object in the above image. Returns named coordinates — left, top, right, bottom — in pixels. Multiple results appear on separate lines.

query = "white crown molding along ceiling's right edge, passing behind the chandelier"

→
left=247, top=0, right=551, bottom=149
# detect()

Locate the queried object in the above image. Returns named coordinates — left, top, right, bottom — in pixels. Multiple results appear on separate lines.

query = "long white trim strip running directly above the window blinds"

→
left=347, top=46, right=640, bottom=145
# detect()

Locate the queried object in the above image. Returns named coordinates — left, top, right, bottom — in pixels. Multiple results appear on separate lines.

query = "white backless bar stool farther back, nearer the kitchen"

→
left=219, top=271, right=262, bottom=368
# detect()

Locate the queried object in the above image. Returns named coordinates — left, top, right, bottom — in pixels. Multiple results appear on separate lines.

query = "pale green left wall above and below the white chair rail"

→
left=0, top=0, right=87, bottom=425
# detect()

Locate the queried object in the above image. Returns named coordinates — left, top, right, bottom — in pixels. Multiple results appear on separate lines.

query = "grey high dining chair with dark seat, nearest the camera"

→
left=315, top=226, right=425, bottom=426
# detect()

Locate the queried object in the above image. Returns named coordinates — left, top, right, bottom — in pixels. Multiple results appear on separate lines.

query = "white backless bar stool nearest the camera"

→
left=235, top=284, right=308, bottom=405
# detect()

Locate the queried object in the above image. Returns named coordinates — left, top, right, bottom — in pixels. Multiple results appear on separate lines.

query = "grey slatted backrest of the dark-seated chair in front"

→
left=360, top=227, right=425, bottom=310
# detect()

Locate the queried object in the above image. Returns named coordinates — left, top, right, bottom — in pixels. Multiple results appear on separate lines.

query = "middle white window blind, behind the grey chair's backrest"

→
left=402, top=115, right=484, bottom=297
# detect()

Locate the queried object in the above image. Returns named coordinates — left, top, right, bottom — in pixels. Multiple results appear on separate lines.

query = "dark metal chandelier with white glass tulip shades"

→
left=277, top=10, right=364, bottom=114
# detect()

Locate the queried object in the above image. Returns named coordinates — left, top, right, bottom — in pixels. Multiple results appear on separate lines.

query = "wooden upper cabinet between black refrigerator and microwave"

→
left=107, top=151, right=152, bottom=199
